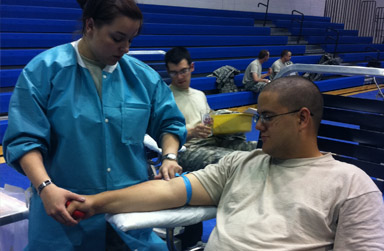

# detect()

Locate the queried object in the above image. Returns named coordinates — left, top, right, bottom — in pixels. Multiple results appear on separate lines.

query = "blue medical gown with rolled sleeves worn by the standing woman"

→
left=3, top=44, right=186, bottom=250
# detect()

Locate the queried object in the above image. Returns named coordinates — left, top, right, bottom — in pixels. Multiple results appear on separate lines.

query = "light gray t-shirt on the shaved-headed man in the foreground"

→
left=193, top=149, right=384, bottom=251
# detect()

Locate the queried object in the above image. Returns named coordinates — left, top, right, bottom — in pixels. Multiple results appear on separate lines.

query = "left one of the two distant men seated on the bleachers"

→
left=243, top=50, right=272, bottom=93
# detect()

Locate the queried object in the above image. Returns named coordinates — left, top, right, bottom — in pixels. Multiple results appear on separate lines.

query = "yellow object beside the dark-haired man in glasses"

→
left=212, top=113, right=253, bottom=135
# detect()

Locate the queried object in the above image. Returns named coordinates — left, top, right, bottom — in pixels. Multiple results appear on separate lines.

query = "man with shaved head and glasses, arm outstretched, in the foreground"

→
left=68, top=76, right=384, bottom=251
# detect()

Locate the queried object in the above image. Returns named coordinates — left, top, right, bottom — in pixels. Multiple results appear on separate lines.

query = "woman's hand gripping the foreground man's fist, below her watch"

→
left=40, top=184, right=85, bottom=226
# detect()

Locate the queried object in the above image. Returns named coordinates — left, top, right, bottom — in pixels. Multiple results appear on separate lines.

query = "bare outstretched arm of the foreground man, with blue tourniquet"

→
left=67, top=174, right=214, bottom=218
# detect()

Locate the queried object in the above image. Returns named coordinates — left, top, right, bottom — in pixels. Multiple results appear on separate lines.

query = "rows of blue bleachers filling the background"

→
left=0, top=0, right=384, bottom=144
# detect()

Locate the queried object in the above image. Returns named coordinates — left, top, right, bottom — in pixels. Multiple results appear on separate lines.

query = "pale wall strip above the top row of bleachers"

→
left=137, top=0, right=326, bottom=16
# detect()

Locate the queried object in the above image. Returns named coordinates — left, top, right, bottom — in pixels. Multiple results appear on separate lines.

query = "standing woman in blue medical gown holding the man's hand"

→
left=3, top=0, right=187, bottom=250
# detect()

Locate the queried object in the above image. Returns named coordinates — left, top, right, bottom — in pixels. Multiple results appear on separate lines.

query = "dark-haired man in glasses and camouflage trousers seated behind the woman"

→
left=165, top=47, right=257, bottom=171
